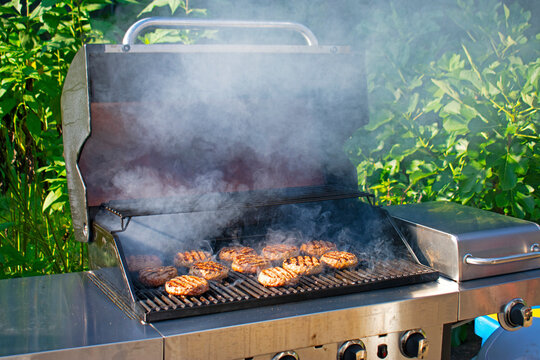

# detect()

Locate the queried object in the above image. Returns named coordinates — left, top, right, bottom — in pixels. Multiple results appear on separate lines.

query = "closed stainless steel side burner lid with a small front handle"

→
left=388, top=202, right=540, bottom=281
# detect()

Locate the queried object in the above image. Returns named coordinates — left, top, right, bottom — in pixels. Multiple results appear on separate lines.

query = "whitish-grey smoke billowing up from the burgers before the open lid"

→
left=80, top=1, right=420, bottom=257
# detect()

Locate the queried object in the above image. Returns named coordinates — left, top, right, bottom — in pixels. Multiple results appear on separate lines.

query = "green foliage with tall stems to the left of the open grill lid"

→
left=0, top=0, right=211, bottom=278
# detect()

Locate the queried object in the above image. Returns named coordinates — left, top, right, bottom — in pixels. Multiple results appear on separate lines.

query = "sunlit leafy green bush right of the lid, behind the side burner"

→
left=348, top=0, right=540, bottom=220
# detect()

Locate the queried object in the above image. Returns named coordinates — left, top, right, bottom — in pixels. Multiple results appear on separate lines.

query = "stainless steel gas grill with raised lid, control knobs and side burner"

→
left=0, top=18, right=540, bottom=360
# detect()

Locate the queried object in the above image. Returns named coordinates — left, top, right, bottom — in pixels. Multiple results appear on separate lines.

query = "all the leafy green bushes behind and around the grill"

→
left=0, top=0, right=540, bottom=278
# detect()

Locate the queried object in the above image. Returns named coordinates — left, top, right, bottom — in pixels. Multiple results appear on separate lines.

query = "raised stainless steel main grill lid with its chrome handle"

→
left=62, top=19, right=367, bottom=241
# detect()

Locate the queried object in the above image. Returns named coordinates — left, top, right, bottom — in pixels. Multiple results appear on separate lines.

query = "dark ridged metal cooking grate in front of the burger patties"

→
left=135, top=259, right=439, bottom=322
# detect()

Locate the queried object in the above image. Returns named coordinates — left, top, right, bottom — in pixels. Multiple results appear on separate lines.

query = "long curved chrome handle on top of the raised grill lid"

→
left=122, top=17, right=319, bottom=48
